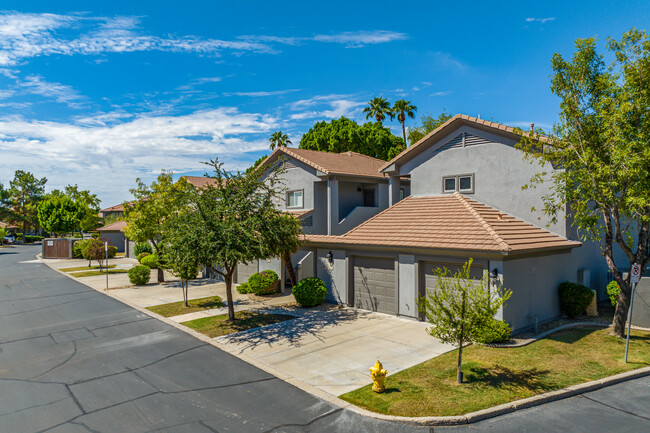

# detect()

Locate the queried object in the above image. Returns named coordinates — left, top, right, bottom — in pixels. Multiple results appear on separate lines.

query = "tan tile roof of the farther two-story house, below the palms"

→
left=262, top=146, right=386, bottom=178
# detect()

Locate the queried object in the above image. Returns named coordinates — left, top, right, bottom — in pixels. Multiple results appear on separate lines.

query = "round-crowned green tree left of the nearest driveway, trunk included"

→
left=165, top=160, right=298, bottom=320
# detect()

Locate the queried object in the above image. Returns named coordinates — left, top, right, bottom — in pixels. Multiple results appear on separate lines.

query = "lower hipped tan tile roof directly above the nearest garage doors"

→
left=306, top=193, right=581, bottom=253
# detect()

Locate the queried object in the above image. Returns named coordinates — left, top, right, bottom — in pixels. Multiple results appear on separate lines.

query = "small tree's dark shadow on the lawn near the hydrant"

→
left=463, top=365, right=556, bottom=393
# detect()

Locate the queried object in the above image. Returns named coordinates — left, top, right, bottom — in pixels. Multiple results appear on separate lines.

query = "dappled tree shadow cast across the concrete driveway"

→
left=215, top=308, right=369, bottom=353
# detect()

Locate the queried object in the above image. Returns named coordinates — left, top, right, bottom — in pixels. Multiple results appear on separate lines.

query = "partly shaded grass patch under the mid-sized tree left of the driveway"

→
left=182, top=311, right=293, bottom=337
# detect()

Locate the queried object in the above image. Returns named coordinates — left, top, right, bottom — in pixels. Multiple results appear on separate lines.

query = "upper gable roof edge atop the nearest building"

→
left=380, top=114, right=548, bottom=171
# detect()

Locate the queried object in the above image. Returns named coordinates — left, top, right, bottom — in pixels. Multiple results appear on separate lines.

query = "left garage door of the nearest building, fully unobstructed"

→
left=354, top=257, right=397, bottom=314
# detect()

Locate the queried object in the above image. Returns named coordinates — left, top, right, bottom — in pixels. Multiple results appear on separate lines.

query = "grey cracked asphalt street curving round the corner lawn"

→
left=0, top=246, right=650, bottom=433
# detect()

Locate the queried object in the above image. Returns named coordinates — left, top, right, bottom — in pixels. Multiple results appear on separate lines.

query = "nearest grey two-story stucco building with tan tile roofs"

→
left=303, top=115, right=607, bottom=330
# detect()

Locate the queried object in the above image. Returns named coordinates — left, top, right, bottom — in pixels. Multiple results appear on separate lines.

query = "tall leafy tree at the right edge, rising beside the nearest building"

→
left=520, top=29, right=650, bottom=337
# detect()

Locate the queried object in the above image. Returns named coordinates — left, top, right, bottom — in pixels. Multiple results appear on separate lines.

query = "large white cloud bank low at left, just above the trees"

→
left=0, top=108, right=279, bottom=204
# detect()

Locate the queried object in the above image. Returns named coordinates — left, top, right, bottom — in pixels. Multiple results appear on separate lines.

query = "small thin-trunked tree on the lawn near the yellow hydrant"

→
left=420, top=259, right=512, bottom=383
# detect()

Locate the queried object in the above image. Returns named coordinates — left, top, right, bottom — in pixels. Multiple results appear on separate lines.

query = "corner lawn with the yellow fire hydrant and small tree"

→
left=341, top=328, right=650, bottom=416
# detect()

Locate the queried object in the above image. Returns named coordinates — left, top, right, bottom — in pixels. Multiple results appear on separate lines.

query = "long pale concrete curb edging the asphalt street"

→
left=37, top=254, right=650, bottom=426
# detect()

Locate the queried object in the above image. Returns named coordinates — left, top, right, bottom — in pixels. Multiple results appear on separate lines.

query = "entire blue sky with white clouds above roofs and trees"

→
left=0, top=0, right=650, bottom=206
